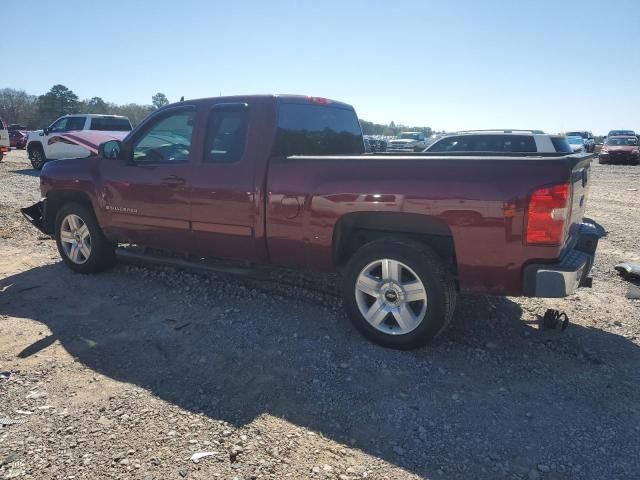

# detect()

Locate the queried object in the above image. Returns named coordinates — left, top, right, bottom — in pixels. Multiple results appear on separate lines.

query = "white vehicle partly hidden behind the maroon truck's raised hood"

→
left=27, top=114, right=131, bottom=170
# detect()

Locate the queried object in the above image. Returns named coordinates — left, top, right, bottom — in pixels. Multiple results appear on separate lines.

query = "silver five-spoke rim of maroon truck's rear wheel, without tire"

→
left=355, top=258, right=427, bottom=335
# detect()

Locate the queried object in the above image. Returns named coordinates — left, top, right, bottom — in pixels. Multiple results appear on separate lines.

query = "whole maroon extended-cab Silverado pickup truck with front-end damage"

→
left=23, top=95, right=598, bottom=348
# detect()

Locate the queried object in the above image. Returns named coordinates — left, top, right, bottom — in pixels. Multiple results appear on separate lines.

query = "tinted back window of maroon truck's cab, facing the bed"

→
left=275, top=103, right=364, bottom=155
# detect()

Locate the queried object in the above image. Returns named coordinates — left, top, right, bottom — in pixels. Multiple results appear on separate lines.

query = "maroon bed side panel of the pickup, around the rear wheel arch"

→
left=267, top=156, right=571, bottom=295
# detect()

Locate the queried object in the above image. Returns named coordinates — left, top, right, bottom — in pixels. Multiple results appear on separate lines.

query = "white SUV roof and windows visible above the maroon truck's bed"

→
left=424, top=130, right=573, bottom=153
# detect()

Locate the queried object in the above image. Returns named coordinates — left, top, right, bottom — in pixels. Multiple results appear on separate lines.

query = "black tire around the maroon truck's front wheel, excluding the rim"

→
left=55, top=202, right=116, bottom=273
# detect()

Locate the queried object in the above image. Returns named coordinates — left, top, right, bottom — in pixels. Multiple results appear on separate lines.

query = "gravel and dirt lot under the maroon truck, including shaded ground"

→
left=0, top=148, right=640, bottom=480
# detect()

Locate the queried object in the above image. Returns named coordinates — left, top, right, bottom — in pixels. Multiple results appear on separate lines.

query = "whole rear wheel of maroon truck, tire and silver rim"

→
left=342, top=239, right=456, bottom=350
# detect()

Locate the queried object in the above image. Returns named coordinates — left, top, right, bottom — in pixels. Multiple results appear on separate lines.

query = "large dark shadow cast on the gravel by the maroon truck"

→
left=0, top=264, right=640, bottom=478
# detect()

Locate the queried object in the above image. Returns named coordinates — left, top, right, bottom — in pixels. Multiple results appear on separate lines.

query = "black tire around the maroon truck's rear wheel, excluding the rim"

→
left=342, top=238, right=457, bottom=350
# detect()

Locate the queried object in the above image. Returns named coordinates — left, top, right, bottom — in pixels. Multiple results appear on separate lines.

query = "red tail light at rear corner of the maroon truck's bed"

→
left=527, top=183, right=571, bottom=245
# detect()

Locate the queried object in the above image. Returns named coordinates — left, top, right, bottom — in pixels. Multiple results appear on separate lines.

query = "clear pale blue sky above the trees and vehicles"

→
left=0, top=0, right=640, bottom=134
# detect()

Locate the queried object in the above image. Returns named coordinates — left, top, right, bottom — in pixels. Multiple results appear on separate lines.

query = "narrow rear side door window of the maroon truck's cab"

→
left=205, top=103, right=249, bottom=163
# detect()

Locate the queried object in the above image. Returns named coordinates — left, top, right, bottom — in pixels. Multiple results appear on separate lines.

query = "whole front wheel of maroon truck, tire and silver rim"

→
left=55, top=203, right=115, bottom=273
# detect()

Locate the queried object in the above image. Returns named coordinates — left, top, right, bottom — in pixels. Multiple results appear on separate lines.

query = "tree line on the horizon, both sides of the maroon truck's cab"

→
left=0, top=84, right=433, bottom=136
